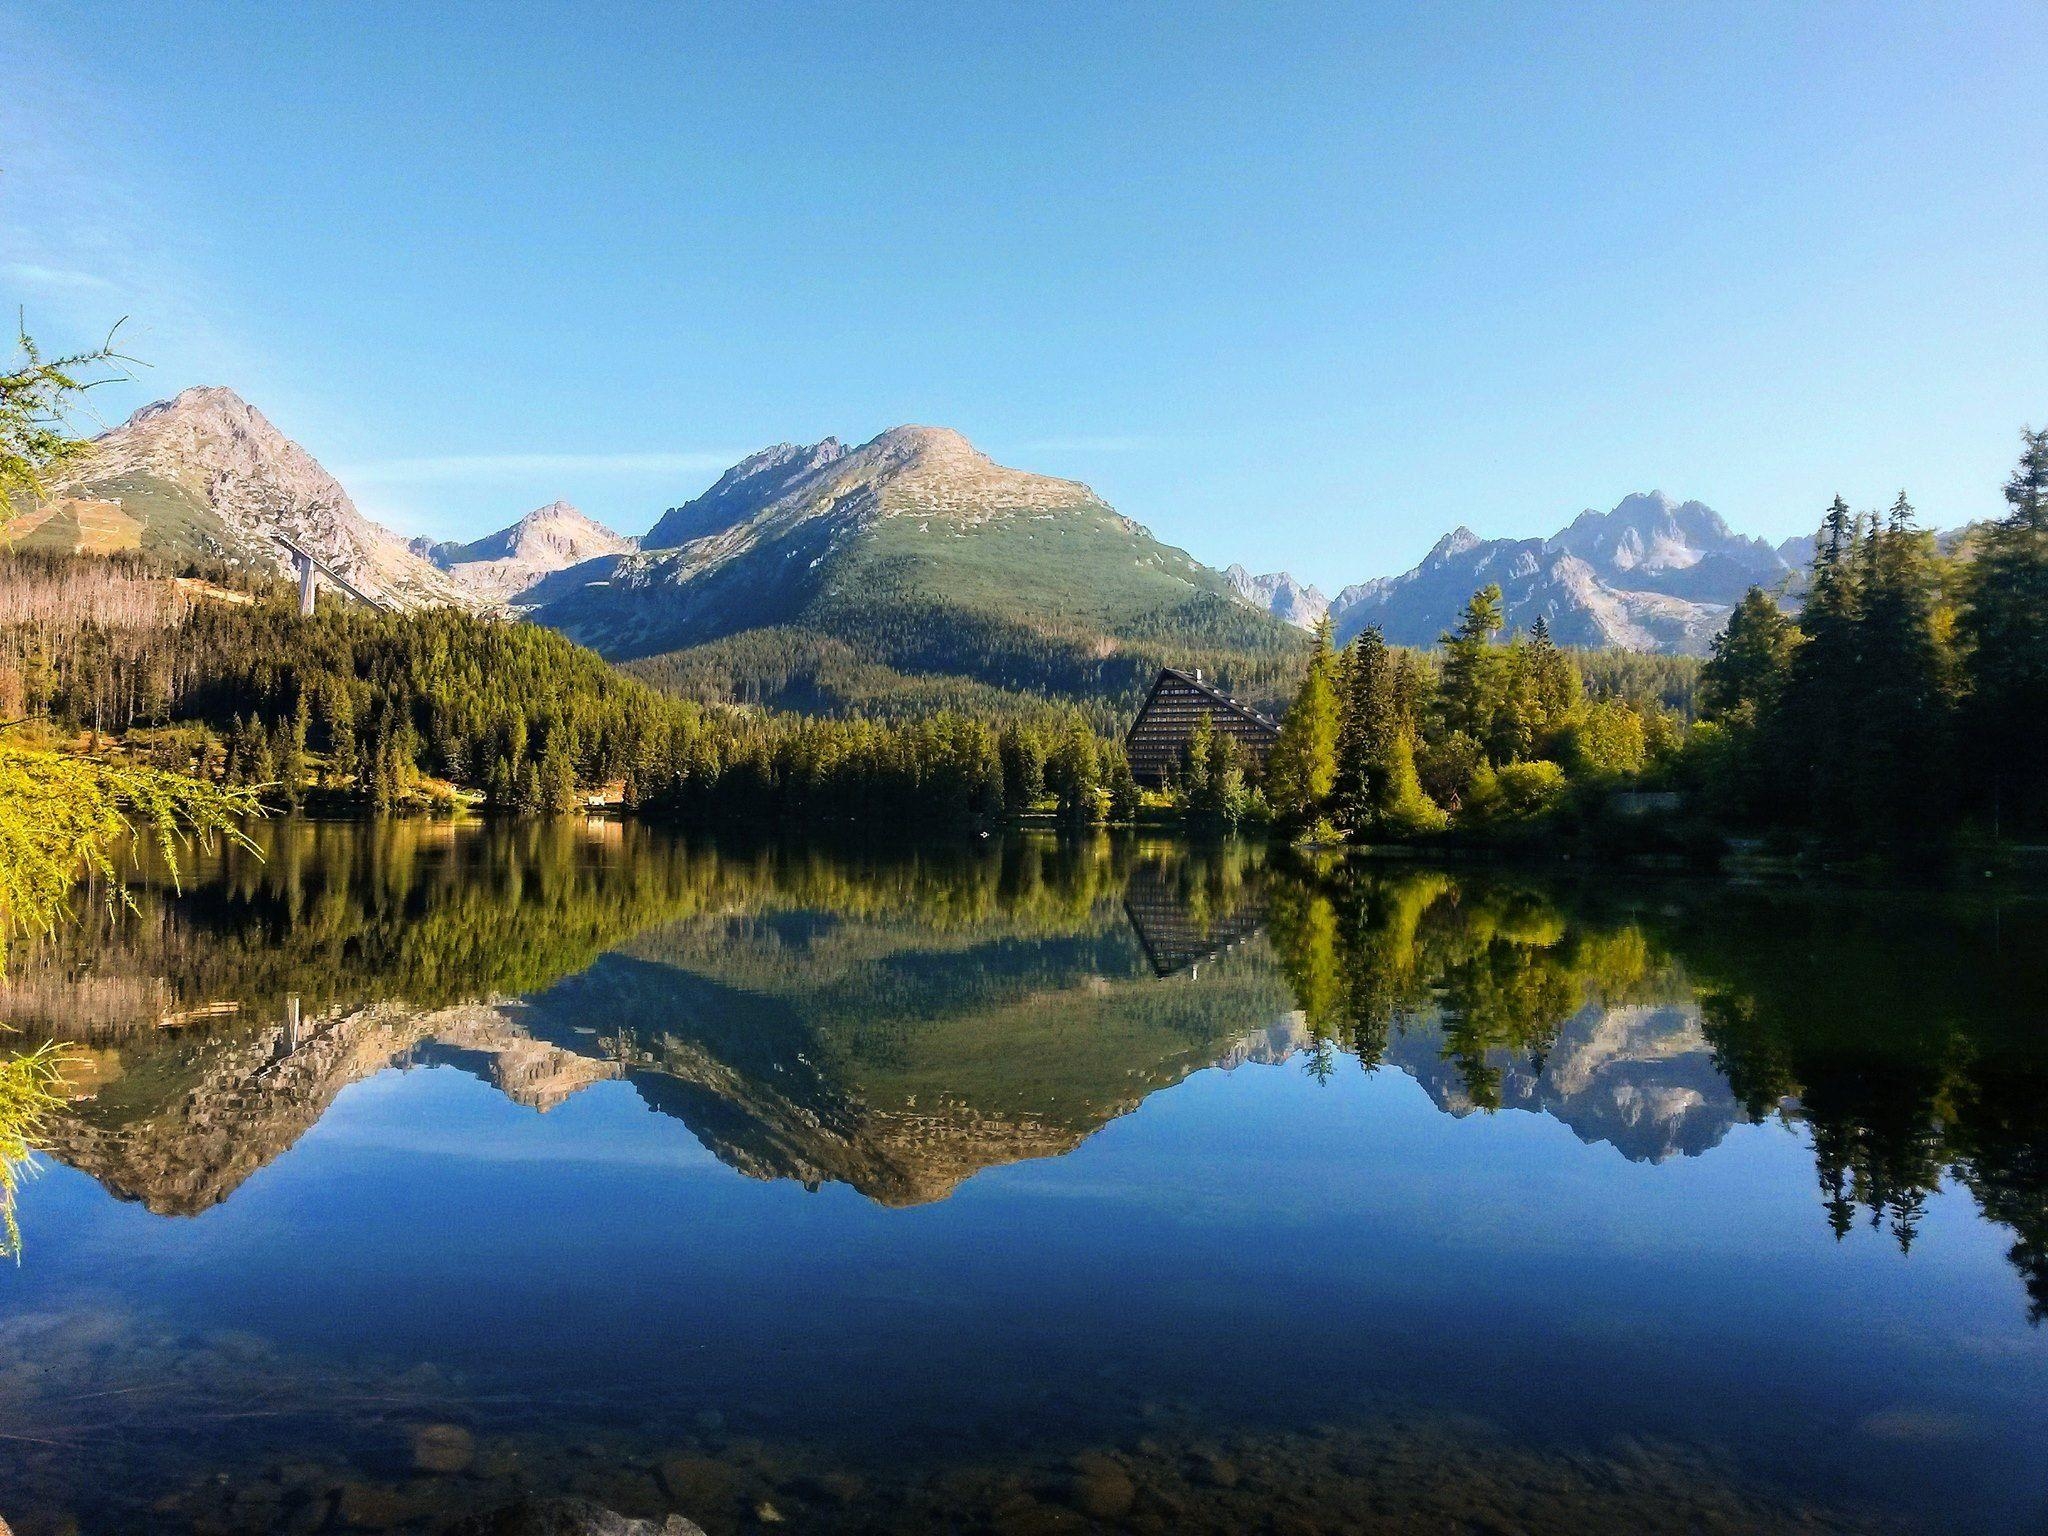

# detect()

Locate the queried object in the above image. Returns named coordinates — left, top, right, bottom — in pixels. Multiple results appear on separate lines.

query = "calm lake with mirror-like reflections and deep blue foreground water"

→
left=0, top=823, right=2048, bottom=1536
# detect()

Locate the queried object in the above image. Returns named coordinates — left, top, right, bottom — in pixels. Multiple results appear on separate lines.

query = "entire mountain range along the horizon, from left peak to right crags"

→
left=8, top=387, right=1835, bottom=692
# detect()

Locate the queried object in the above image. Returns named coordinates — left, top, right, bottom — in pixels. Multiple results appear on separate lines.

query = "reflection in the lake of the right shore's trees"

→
left=1266, top=868, right=2048, bottom=1321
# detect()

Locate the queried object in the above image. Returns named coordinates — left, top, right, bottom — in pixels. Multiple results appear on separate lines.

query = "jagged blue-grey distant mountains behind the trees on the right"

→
left=1329, top=492, right=1800, bottom=655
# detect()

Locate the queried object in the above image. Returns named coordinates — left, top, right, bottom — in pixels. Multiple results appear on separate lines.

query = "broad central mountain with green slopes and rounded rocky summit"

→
left=530, top=426, right=1300, bottom=713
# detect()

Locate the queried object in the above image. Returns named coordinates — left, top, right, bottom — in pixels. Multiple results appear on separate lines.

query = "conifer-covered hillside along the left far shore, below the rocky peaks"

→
left=0, top=555, right=1128, bottom=827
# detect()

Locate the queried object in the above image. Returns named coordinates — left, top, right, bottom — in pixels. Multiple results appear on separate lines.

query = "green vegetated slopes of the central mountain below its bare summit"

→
left=606, top=504, right=1307, bottom=735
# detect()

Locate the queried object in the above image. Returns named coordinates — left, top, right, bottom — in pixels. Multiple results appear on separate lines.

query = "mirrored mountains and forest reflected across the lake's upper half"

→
left=0, top=823, right=2048, bottom=1530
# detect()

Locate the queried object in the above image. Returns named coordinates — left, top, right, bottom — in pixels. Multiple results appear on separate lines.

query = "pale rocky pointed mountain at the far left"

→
left=8, top=387, right=469, bottom=606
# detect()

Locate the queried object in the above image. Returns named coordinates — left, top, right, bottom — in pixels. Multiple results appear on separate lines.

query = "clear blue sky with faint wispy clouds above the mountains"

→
left=0, top=0, right=2048, bottom=590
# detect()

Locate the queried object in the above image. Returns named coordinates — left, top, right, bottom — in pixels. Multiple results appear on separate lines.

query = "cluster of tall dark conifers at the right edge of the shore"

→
left=1675, top=450, right=2048, bottom=854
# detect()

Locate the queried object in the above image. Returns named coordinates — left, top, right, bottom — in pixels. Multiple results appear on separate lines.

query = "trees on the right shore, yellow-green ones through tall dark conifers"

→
left=1253, top=432, right=2048, bottom=854
